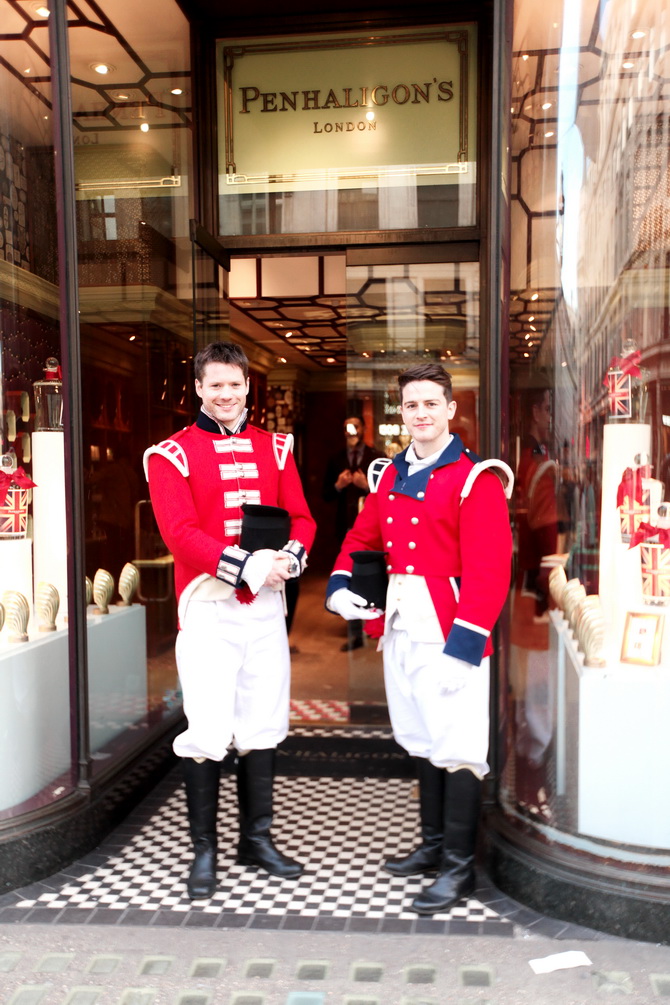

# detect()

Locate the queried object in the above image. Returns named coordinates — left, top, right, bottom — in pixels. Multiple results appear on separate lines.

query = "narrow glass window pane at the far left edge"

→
left=0, top=2, right=72, bottom=820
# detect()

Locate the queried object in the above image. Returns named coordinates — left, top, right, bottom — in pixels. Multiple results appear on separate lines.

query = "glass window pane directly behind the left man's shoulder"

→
left=68, top=2, right=193, bottom=772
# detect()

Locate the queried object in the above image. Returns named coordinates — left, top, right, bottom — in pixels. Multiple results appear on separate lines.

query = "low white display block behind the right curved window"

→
left=550, top=608, right=670, bottom=848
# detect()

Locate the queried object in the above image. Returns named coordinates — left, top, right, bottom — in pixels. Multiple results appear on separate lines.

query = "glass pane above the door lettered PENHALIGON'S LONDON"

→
left=217, top=24, right=477, bottom=235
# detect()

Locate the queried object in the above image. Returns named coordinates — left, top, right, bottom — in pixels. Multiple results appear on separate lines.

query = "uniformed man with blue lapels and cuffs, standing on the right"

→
left=326, top=363, right=513, bottom=915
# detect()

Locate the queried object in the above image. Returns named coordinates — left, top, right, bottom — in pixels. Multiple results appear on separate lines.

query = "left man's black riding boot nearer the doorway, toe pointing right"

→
left=237, top=748, right=302, bottom=879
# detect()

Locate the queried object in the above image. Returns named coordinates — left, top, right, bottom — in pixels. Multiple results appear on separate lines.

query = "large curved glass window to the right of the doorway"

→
left=501, top=0, right=670, bottom=869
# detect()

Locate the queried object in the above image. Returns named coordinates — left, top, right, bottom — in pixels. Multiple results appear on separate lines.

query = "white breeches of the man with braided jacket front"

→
left=173, top=587, right=290, bottom=761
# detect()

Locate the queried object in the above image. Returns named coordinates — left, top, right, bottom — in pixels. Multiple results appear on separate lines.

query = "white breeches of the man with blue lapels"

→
left=383, top=629, right=490, bottom=778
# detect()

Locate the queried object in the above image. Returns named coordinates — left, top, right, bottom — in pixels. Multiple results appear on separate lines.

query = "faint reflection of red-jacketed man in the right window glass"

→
left=510, top=386, right=561, bottom=821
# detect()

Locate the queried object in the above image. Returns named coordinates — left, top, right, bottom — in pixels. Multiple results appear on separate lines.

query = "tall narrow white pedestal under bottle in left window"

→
left=28, top=432, right=67, bottom=624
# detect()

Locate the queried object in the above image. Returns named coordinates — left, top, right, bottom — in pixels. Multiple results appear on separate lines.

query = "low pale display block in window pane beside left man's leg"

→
left=86, top=604, right=148, bottom=753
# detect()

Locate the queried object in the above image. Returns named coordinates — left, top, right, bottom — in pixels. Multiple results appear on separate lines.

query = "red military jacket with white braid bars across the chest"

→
left=145, top=412, right=316, bottom=601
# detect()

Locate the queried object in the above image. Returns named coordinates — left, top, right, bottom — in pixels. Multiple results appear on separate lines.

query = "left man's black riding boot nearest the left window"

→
left=182, top=757, right=221, bottom=900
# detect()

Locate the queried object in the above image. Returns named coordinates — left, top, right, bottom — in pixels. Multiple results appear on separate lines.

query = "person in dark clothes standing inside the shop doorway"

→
left=322, top=415, right=384, bottom=652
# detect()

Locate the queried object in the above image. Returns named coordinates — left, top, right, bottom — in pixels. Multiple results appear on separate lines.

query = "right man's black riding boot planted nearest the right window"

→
left=412, top=768, right=481, bottom=915
